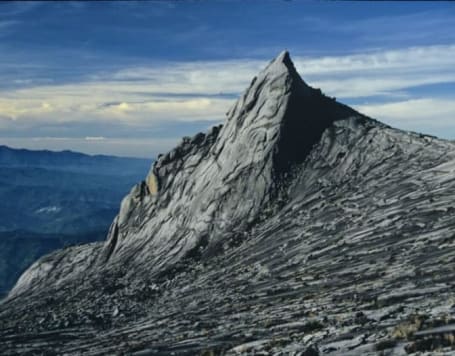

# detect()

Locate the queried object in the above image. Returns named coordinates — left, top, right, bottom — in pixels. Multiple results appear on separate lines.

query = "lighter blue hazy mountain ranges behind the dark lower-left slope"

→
left=0, top=146, right=150, bottom=234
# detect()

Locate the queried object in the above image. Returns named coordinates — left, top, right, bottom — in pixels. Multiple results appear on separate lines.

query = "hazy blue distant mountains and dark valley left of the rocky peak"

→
left=0, top=146, right=150, bottom=294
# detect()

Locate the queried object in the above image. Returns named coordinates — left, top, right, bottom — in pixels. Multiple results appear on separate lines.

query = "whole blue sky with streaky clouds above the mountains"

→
left=0, top=0, right=455, bottom=158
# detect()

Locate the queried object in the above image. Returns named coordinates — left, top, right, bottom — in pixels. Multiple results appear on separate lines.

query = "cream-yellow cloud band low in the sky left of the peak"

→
left=0, top=88, right=232, bottom=125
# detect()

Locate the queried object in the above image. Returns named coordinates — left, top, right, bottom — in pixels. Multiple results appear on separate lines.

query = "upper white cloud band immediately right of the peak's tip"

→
left=296, top=45, right=455, bottom=98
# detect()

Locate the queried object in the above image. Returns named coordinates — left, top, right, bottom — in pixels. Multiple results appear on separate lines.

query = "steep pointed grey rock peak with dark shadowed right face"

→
left=12, top=51, right=361, bottom=293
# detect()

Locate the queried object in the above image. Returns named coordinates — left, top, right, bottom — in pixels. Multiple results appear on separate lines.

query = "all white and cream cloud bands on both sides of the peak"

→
left=0, top=45, right=455, bottom=154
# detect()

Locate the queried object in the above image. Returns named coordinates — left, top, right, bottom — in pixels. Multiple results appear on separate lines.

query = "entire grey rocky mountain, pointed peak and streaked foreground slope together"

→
left=0, top=52, right=455, bottom=355
